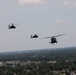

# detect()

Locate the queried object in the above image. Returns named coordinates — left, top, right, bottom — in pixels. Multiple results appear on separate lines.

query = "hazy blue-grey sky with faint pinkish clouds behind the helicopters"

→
left=0, top=0, right=76, bottom=52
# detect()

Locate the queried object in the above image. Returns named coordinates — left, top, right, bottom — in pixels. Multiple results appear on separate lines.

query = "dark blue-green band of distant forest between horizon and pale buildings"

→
left=0, top=47, right=76, bottom=61
